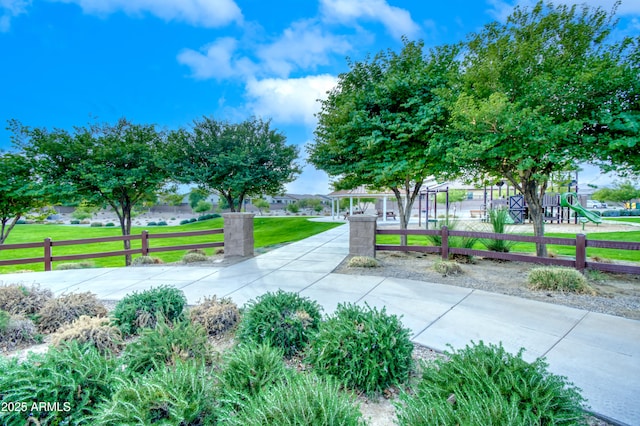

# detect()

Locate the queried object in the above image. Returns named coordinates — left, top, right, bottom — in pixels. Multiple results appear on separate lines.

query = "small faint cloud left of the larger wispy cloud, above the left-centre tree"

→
left=178, top=37, right=255, bottom=79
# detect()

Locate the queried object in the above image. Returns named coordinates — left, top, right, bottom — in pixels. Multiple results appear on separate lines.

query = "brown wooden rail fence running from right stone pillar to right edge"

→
left=376, top=226, right=640, bottom=274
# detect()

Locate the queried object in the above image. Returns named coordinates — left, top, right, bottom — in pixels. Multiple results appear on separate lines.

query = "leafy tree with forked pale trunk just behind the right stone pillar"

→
left=307, top=40, right=457, bottom=241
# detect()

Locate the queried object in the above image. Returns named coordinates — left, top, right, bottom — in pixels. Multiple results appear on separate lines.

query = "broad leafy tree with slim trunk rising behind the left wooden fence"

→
left=11, top=118, right=168, bottom=265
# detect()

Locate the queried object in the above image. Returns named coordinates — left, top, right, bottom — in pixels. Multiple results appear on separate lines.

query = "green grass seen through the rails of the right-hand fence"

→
left=376, top=229, right=640, bottom=262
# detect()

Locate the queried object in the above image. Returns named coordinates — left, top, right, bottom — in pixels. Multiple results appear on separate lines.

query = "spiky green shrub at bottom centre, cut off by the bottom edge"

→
left=225, top=374, right=365, bottom=426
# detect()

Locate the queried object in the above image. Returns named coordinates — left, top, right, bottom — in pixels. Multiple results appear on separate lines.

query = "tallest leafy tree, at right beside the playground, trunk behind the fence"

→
left=440, top=2, right=638, bottom=256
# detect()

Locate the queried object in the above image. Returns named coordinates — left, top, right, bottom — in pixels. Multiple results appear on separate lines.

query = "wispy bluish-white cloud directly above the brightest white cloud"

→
left=258, top=20, right=351, bottom=77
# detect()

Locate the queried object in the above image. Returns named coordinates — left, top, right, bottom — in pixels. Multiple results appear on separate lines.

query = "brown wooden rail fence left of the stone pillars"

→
left=0, top=228, right=224, bottom=271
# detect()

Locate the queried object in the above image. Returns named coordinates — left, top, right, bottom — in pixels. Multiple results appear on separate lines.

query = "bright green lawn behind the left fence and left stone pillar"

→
left=0, top=217, right=340, bottom=273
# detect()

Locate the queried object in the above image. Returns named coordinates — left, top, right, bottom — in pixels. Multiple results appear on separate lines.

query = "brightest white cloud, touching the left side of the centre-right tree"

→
left=246, top=74, right=338, bottom=127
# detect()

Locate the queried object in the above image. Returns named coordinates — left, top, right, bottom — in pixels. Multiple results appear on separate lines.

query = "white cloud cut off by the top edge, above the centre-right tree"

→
left=320, top=0, right=420, bottom=38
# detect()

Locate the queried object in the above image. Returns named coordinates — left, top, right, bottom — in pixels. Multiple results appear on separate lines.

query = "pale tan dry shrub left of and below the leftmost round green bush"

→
left=51, top=315, right=124, bottom=354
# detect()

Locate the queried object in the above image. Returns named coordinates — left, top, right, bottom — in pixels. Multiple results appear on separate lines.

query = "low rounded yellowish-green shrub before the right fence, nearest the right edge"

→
left=527, top=266, right=596, bottom=295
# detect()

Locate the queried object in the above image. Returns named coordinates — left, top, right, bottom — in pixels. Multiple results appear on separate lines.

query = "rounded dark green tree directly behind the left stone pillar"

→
left=171, top=117, right=300, bottom=212
